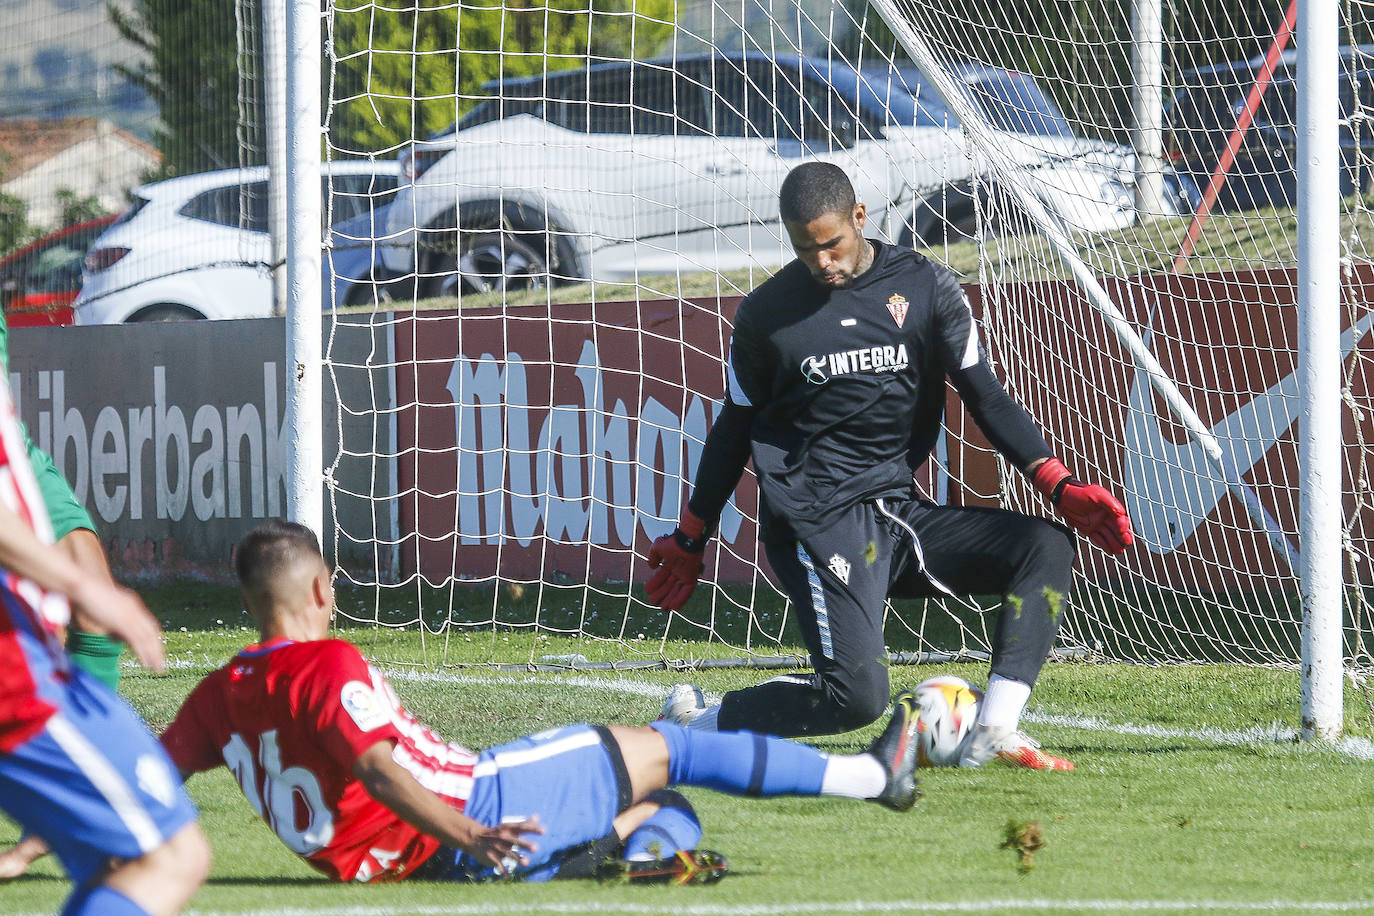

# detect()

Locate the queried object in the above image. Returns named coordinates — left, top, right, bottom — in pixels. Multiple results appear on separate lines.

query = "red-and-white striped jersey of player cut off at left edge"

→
left=0, top=378, right=70, bottom=753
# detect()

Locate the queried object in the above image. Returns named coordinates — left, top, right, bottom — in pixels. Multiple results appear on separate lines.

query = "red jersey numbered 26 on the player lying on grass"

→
left=162, top=639, right=477, bottom=882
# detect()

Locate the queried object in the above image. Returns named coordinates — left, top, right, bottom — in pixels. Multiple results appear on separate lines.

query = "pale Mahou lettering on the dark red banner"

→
left=448, top=341, right=743, bottom=547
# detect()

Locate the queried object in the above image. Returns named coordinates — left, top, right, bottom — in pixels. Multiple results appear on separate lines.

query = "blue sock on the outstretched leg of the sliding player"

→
left=650, top=722, right=827, bottom=795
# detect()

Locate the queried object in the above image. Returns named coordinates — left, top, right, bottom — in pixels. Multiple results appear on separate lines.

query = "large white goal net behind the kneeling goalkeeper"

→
left=316, top=0, right=1374, bottom=672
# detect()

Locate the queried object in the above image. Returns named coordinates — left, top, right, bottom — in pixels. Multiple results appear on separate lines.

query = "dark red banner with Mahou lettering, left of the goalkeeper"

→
left=396, top=299, right=758, bottom=581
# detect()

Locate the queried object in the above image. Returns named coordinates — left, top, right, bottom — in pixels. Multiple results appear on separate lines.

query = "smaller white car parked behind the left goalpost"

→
left=73, top=161, right=397, bottom=324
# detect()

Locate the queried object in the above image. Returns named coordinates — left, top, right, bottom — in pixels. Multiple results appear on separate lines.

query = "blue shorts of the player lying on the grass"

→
left=415, top=725, right=631, bottom=882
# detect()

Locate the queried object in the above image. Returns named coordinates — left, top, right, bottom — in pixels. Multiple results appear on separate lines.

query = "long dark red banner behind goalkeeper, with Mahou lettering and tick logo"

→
left=394, top=265, right=1374, bottom=589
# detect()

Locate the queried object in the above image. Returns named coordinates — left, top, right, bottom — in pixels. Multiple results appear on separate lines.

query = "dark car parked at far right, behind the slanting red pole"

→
left=1165, top=44, right=1374, bottom=210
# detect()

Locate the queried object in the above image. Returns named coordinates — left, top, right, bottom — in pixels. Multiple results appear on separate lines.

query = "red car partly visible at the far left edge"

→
left=0, top=216, right=117, bottom=328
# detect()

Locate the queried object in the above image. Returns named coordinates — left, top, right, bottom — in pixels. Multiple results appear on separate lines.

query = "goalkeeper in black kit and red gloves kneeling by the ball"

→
left=646, top=162, right=1134, bottom=769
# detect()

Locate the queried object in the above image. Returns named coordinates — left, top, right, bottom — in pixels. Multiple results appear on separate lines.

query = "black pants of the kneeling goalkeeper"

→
left=719, top=499, right=1076, bottom=737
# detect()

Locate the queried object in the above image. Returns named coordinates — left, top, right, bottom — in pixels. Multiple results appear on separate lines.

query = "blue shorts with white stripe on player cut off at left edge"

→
left=0, top=670, right=196, bottom=882
